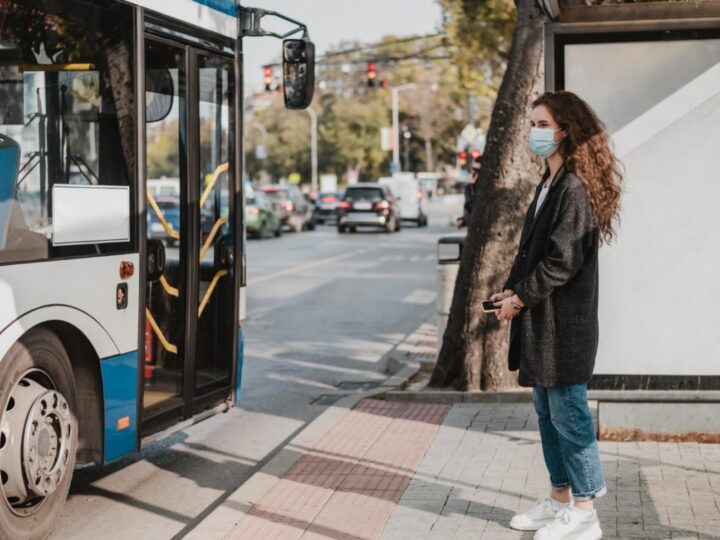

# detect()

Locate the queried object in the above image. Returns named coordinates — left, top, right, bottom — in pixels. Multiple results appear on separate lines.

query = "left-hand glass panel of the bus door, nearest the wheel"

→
left=143, top=38, right=188, bottom=419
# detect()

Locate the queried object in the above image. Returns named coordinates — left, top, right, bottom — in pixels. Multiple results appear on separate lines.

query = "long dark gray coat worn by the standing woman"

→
left=504, top=168, right=600, bottom=387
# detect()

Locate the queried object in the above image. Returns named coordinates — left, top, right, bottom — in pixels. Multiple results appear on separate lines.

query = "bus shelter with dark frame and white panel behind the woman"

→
left=542, top=0, right=720, bottom=431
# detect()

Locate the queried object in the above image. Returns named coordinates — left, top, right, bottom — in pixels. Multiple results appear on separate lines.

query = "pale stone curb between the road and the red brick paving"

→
left=184, top=323, right=427, bottom=540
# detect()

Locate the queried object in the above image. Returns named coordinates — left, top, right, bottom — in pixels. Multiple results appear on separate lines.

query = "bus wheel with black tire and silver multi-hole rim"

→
left=0, top=328, right=78, bottom=539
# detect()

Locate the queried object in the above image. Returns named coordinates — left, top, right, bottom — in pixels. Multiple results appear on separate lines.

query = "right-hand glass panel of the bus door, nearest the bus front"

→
left=195, top=53, right=235, bottom=409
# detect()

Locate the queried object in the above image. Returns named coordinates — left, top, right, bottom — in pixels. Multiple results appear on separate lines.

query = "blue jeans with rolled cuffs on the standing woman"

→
left=533, top=384, right=607, bottom=501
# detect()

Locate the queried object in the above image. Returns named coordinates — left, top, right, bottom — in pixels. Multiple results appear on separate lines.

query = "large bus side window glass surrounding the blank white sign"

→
left=0, top=0, right=134, bottom=263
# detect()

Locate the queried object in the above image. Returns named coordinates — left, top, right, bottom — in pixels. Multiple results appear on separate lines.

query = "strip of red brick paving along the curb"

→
left=226, top=400, right=448, bottom=540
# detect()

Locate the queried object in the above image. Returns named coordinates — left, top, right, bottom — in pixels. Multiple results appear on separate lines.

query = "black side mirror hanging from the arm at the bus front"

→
left=283, top=38, right=315, bottom=109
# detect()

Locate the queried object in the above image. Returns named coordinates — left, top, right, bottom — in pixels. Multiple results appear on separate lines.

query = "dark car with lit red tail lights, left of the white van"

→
left=338, top=183, right=400, bottom=233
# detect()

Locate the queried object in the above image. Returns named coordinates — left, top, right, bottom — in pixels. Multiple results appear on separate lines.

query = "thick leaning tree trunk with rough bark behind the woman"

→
left=430, top=0, right=543, bottom=390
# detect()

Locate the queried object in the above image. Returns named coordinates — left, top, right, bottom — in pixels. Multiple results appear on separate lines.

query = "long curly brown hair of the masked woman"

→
left=532, top=90, right=623, bottom=243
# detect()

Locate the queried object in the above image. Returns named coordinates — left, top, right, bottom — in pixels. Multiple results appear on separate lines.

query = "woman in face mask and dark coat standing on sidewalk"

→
left=492, top=91, right=622, bottom=540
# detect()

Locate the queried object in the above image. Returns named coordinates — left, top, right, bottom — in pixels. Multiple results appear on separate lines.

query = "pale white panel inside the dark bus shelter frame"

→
left=565, top=40, right=720, bottom=375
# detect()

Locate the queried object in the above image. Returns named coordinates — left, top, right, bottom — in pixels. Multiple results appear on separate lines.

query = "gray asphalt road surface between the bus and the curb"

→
left=51, top=199, right=460, bottom=540
